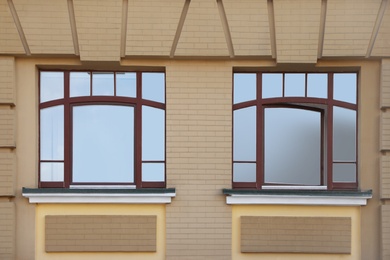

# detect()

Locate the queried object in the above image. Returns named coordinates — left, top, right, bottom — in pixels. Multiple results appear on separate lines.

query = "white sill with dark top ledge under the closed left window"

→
left=22, top=188, right=176, bottom=204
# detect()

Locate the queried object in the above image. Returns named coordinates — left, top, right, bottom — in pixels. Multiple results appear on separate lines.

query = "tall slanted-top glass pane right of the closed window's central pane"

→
left=142, top=106, right=165, bottom=161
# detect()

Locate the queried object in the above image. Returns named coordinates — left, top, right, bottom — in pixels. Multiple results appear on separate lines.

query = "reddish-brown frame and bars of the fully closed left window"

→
left=38, top=70, right=166, bottom=189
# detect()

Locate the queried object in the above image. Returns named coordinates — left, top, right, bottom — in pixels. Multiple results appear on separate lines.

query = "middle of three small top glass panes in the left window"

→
left=92, top=72, right=114, bottom=96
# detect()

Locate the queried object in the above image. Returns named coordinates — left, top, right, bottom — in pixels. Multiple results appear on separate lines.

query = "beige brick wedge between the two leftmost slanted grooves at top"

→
left=13, top=0, right=74, bottom=54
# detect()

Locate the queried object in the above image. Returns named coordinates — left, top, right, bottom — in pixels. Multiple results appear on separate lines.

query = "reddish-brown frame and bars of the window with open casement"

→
left=232, top=71, right=359, bottom=190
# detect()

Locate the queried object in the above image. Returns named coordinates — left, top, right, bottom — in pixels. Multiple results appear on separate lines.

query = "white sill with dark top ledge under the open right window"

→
left=222, top=189, right=372, bottom=206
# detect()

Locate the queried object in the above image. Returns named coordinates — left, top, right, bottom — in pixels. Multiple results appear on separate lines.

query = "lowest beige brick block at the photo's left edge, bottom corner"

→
left=0, top=202, right=15, bottom=260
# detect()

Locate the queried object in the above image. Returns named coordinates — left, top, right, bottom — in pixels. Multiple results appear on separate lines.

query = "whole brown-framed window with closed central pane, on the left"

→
left=39, top=71, right=165, bottom=188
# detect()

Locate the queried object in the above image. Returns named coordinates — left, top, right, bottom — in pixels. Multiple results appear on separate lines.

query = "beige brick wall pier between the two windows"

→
left=166, top=62, right=232, bottom=260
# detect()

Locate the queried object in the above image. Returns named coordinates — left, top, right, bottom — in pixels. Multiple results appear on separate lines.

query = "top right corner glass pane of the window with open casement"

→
left=333, top=73, right=356, bottom=104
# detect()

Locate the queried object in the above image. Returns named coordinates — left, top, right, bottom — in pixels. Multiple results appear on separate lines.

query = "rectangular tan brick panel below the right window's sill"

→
left=241, top=216, right=351, bottom=254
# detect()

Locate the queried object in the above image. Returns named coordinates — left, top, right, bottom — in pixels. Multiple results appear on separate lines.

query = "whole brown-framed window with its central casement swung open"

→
left=232, top=72, right=357, bottom=190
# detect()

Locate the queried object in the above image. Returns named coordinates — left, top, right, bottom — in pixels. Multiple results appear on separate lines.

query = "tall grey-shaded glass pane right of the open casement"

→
left=333, top=107, right=356, bottom=162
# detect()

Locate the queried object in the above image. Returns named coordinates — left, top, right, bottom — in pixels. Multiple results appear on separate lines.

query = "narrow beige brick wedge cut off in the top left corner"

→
left=0, top=1, right=25, bottom=54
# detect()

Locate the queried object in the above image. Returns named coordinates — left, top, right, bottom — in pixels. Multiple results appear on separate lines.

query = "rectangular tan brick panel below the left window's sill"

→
left=45, top=215, right=157, bottom=252
